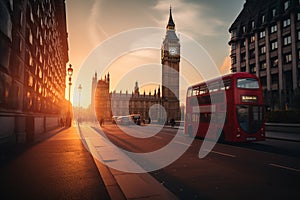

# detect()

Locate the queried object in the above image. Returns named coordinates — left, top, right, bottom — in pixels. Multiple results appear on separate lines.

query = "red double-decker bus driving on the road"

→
left=185, top=72, right=265, bottom=142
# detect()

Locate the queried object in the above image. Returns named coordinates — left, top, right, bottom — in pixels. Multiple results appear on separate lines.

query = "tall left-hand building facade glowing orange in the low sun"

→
left=0, top=0, right=68, bottom=145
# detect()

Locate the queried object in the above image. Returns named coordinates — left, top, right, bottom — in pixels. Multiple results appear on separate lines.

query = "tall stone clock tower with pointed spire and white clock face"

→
left=161, top=7, right=180, bottom=121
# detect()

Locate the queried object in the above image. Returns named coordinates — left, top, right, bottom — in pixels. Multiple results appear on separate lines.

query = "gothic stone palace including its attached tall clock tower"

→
left=92, top=8, right=181, bottom=122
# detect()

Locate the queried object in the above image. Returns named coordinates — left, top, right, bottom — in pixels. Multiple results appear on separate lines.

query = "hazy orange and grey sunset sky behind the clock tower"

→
left=66, top=0, right=245, bottom=107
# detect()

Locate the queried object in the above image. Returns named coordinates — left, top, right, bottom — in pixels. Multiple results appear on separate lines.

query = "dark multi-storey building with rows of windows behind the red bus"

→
left=229, top=0, right=300, bottom=110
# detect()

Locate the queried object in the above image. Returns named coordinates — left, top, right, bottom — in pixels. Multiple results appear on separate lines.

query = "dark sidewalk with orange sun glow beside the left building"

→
left=0, top=127, right=110, bottom=200
